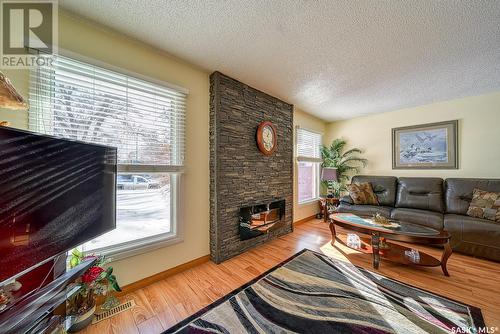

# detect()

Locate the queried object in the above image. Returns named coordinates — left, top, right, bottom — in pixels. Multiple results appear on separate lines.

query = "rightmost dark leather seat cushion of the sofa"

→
left=444, top=214, right=500, bottom=249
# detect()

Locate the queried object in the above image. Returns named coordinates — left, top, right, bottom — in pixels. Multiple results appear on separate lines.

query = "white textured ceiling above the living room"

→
left=59, top=0, right=500, bottom=121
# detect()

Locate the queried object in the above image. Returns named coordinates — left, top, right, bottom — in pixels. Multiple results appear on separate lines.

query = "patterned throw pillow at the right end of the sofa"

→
left=467, top=189, right=500, bottom=223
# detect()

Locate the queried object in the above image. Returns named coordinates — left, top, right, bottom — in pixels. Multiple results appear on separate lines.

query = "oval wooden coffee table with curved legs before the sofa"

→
left=329, top=213, right=452, bottom=276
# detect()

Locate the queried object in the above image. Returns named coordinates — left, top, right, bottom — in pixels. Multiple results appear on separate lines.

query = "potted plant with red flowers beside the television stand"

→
left=67, top=249, right=121, bottom=332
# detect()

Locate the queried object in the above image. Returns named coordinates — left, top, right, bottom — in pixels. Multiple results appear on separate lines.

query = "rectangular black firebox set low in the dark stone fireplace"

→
left=239, top=199, right=285, bottom=240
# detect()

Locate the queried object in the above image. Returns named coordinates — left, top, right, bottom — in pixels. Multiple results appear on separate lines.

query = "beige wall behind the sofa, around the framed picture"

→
left=326, top=92, right=500, bottom=178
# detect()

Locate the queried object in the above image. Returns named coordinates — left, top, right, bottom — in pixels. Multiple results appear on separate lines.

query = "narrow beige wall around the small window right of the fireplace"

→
left=293, top=107, right=326, bottom=222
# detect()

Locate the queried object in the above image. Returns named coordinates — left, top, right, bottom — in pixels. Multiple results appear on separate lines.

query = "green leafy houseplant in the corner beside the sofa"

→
left=321, top=138, right=368, bottom=198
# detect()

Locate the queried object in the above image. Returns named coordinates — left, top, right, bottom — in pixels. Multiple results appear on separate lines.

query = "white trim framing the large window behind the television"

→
left=29, top=48, right=189, bottom=261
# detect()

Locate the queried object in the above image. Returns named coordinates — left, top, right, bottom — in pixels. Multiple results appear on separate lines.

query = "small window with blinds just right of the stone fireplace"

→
left=297, top=128, right=321, bottom=204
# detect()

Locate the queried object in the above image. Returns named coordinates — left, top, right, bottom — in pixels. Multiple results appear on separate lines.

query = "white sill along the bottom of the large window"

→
left=89, top=233, right=183, bottom=261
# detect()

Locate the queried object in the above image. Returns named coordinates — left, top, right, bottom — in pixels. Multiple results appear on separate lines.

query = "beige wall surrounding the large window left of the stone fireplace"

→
left=0, top=13, right=209, bottom=285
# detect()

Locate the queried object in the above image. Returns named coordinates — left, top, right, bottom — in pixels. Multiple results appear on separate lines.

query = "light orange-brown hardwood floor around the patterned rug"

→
left=80, top=220, right=500, bottom=334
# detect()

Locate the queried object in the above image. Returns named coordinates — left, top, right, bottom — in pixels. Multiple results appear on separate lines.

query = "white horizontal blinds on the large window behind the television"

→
left=29, top=56, right=186, bottom=171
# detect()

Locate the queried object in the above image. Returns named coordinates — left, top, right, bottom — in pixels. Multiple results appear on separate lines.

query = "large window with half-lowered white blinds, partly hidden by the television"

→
left=29, top=56, right=186, bottom=254
